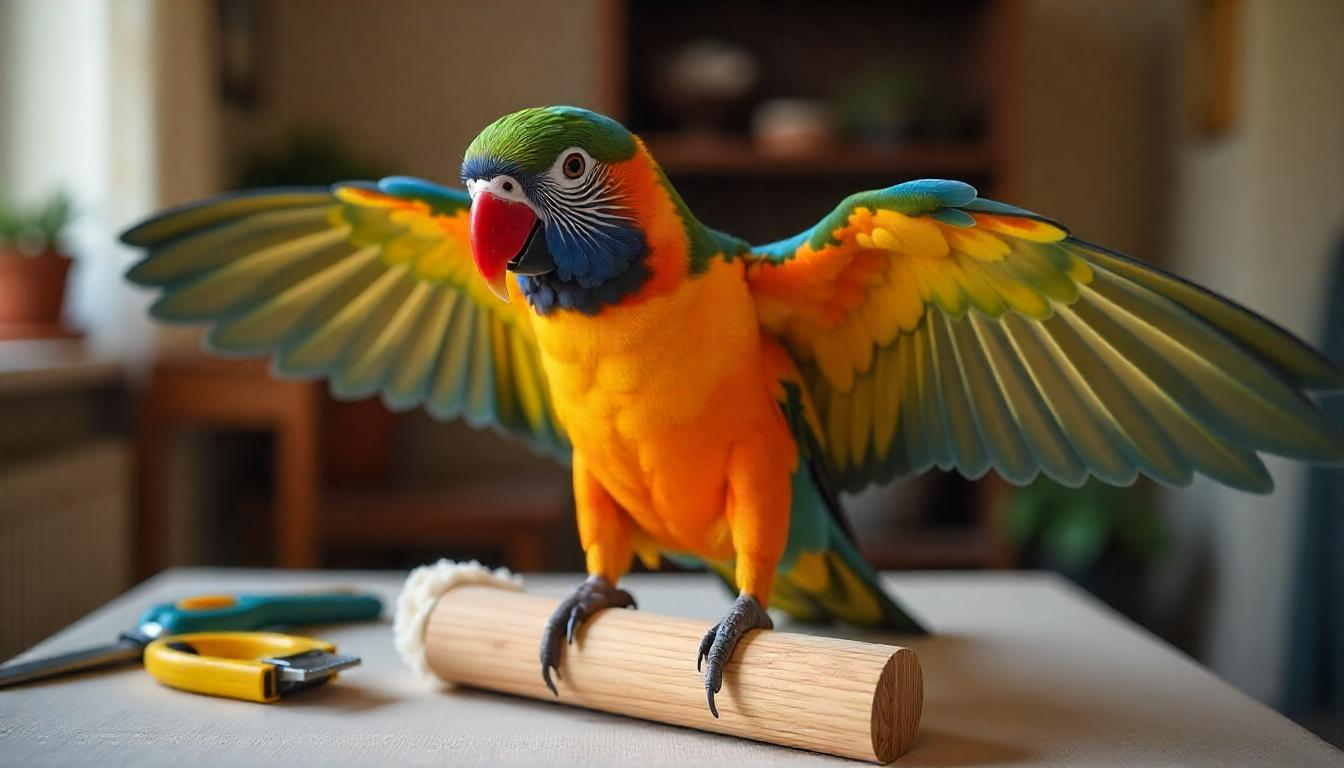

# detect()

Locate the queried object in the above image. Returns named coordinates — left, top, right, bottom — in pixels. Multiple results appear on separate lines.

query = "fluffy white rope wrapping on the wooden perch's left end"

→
left=392, top=560, right=523, bottom=678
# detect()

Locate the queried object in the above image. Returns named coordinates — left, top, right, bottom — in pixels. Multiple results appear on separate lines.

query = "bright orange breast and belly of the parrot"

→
left=534, top=260, right=793, bottom=557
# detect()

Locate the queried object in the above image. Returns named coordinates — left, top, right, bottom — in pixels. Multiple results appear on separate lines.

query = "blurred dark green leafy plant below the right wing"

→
left=1000, top=476, right=1167, bottom=623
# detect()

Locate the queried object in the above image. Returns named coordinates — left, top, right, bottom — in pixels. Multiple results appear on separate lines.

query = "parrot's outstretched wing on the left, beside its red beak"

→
left=122, top=178, right=570, bottom=460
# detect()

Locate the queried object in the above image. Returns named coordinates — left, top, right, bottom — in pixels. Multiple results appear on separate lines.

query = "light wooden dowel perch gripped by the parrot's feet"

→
left=425, top=585, right=923, bottom=763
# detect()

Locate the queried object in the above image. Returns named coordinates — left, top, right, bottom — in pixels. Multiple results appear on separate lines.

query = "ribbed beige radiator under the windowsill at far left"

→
left=0, top=438, right=132, bottom=659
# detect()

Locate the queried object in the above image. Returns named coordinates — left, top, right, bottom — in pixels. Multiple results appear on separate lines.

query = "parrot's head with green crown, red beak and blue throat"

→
left=462, top=106, right=649, bottom=313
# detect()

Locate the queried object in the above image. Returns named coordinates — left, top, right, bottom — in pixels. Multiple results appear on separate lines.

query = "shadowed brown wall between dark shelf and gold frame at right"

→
left=1013, top=0, right=1179, bottom=261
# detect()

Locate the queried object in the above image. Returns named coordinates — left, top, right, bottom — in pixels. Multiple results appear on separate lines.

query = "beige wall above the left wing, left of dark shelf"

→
left=226, top=0, right=602, bottom=183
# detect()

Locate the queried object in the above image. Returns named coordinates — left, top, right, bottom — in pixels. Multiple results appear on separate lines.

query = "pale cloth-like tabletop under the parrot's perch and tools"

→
left=0, top=569, right=1344, bottom=768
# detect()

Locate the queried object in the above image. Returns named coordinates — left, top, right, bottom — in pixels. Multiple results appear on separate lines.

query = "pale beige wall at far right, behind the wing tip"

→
left=1172, top=0, right=1344, bottom=702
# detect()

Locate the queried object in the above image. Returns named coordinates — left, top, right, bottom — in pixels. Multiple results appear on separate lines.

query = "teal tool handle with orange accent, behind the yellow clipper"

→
left=140, top=592, right=383, bottom=636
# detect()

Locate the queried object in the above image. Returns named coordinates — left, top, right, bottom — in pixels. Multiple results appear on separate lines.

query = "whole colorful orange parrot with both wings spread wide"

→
left=122, top=106, right=1344, bottom=717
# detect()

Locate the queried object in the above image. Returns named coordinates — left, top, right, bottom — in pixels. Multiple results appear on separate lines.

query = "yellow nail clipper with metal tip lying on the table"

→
left=145, top=632, right=359, bottom=703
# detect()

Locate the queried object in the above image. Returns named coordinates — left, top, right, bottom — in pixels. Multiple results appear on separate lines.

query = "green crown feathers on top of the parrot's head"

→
left=465, top=106, right=634, bottom=174
